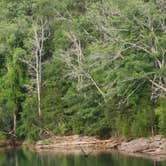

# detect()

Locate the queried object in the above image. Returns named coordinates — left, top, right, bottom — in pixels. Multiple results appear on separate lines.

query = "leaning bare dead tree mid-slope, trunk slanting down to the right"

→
left=61, top=32, right=105, bottom=100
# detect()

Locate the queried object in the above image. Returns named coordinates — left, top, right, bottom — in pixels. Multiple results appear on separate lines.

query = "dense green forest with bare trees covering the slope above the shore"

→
left=0, top=0, right=166, bottom=143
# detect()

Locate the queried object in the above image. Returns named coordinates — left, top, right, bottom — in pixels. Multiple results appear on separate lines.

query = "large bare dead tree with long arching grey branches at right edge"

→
left=87, top=0, right=166, bottom=99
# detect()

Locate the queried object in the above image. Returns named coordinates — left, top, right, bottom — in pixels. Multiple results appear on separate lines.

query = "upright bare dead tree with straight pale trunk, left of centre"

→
left=20, top=18, right=49, bottom=117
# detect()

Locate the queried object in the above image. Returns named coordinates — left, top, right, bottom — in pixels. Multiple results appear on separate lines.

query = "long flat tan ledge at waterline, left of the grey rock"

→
left=35, top=135, right=120, bottom=150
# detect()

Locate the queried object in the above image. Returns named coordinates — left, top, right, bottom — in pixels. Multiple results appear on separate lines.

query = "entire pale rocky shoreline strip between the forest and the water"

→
left=31, top=135, right=166, bottom=161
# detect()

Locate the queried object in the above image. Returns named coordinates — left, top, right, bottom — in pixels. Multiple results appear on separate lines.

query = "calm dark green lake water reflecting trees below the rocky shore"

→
left=0, top=150, right=166, bottom=166
